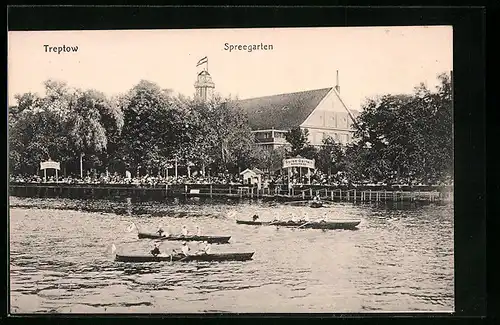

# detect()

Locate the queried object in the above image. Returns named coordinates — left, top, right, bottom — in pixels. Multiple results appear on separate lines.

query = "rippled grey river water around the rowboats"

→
left=9, top=197, right=454, bottom=314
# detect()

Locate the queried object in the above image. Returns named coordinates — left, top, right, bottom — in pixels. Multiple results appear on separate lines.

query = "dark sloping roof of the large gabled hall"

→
left=237, top=87, right=332, bottom=130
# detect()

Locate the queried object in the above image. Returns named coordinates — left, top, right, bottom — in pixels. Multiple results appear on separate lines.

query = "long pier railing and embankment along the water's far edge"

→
left=9, top=183, right=453, bottom=202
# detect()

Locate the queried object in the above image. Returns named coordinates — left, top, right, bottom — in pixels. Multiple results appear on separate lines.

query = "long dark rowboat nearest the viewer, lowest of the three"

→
left=115, top=252, right=254, bottom=263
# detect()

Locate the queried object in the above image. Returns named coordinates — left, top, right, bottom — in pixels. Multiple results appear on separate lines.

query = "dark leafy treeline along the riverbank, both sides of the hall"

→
left=9, top=74, right=453, bottom=184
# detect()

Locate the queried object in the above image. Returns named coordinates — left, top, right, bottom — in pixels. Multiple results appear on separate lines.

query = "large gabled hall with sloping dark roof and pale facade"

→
left=238, top=79, right=359, bottom=148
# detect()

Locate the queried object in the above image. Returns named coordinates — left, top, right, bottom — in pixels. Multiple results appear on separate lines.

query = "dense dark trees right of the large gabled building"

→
left=351, top=74, right=453, bottom=184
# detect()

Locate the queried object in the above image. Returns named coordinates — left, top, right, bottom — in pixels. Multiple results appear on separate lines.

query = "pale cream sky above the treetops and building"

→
left=7, top=26, right=453, bottom=110
